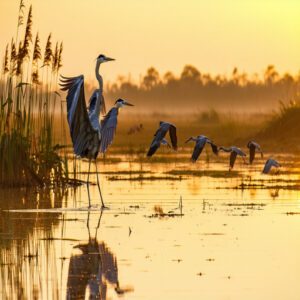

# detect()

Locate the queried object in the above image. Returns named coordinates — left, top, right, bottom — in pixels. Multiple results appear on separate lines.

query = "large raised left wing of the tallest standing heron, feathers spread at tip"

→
left=60, top=75, right=99, bottom=157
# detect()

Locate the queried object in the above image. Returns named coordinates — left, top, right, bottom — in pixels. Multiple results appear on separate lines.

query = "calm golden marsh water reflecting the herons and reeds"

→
left=0, top=156, right=300, bottom=299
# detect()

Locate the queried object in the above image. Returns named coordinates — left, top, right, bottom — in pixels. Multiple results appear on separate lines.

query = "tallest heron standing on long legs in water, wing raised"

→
left=60, top=54, right=114, bottom=208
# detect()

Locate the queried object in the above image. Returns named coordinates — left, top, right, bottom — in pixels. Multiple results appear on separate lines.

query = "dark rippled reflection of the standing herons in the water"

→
left=67, top=211, right=129, bottom=300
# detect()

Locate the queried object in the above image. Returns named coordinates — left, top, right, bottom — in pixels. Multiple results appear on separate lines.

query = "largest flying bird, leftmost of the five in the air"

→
left=147, top=121, right=177, bottom=157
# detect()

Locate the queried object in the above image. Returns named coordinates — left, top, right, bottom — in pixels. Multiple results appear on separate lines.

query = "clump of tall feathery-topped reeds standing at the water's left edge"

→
left=0, top=1, right=68, bottom=186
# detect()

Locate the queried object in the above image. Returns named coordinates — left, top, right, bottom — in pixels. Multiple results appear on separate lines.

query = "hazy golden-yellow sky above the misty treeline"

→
left=0, top=0, right=300, bottom=82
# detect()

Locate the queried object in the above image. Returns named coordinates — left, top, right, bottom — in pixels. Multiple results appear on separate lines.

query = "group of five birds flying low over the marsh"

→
left=147, top=122, right=280, bottom=174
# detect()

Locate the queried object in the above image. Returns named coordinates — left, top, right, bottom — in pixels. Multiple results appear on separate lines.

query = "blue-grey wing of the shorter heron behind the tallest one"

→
left=100, top=107, right=118, bottom=153
